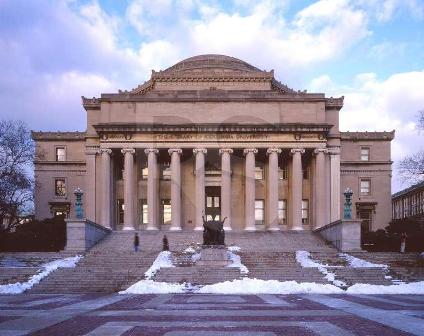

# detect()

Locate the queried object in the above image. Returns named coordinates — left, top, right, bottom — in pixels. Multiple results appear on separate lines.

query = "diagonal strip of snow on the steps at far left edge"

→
left=0, top=255, right=82, bottom=294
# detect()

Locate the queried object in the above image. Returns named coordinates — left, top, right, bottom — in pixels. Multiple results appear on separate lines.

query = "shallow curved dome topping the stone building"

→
left=164, top=54, right=261, bottom=72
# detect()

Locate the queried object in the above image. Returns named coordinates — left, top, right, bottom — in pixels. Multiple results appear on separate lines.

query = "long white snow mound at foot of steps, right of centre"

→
left=196, top=278, right=344, bottom=294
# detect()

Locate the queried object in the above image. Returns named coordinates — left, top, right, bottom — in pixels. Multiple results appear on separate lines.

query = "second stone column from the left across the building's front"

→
left=121, top=148, right=135, bottom=230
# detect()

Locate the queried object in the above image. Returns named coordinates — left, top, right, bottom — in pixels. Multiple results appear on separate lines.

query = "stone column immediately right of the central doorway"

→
left=219, top=148, right=233, bottom=231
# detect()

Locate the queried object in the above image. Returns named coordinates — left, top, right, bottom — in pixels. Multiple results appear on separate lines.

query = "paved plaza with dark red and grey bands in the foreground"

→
left=0, top=294, right=424, bottom=336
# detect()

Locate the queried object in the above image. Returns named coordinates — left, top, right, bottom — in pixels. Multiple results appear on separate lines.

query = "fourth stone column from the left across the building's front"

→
left=168, top=148, right=183, bottom=231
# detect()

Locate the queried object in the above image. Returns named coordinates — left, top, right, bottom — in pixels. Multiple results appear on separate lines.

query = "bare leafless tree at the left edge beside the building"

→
left=0, top=120, right=34, bottom=234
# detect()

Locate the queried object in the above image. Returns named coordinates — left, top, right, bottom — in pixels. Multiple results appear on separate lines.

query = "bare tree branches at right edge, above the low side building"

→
left=398, top=110, right=424, bottom=183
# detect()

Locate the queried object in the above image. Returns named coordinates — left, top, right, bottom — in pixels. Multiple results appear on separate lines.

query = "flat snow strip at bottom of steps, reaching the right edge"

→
left=346, top=281, right=424, bottom=294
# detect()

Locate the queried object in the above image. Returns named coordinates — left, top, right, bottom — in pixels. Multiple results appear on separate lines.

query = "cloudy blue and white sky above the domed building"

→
left=0, top=0, right=424, bottom=190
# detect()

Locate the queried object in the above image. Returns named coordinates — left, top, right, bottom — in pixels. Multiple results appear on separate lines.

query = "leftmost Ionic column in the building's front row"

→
left=100, top=148, right=112, bottom=229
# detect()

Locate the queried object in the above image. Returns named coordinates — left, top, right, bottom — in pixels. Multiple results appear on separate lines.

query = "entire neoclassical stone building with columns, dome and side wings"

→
left=33, top=55, right=394, bottom=231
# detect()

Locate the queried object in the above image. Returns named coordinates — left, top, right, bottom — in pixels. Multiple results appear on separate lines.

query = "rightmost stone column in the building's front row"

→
left=314, top=148, right=328, bottom=229
